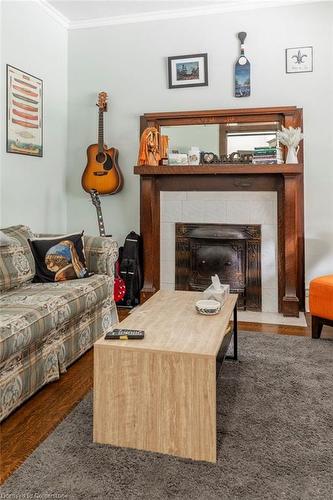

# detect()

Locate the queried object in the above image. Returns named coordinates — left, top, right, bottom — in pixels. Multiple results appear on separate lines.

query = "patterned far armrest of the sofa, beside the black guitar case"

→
left=84, top=236, right=118, bottom=277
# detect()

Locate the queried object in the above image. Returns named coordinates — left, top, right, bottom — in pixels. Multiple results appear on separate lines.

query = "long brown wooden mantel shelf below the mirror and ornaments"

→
left=134, top=163, right=303, bottom=175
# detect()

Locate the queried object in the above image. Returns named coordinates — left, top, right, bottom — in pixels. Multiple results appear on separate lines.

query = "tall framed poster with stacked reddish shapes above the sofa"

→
left=6, top=64, right=43, bottom=156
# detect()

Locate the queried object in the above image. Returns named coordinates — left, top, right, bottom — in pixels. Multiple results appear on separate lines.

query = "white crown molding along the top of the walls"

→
left=35, top=0, right=332, bottom=30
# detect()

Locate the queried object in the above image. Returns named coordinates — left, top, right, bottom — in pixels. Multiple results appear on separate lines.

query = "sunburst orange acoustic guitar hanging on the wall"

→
left=81, top=92, right=123, bottom=194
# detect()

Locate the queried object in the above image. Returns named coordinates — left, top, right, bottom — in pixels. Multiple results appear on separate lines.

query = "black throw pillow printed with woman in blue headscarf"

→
left=29, top=231, right=89, bottom=283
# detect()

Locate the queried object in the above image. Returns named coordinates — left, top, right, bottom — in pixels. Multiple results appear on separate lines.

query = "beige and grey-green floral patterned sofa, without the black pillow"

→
left=0, top=226, right=118, bottom=421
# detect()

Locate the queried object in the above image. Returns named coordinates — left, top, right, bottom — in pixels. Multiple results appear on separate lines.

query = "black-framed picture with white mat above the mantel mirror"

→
left=168, top=54, right=208, bottom=89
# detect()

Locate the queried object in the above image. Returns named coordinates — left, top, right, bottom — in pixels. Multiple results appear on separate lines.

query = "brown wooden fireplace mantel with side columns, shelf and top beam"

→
left=134, top=106, right=305, bottom=316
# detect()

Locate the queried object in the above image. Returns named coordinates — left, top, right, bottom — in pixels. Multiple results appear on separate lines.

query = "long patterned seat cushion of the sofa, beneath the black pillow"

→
left=0, top=275, right=113, bottom=361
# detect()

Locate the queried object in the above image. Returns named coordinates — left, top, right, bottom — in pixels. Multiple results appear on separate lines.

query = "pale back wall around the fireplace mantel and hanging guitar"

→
left=67, top=3, right=333, bottom=288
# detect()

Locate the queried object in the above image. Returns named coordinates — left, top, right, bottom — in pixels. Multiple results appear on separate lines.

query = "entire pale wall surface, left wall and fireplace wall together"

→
left=1, top=1, right=333, bottom=290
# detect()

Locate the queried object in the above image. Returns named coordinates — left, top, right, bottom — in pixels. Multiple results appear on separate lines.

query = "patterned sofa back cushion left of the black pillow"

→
left=0, top=226, right=35, bottom=291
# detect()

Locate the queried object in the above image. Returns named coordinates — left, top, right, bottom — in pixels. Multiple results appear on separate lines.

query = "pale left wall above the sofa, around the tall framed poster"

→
left=1, top=1, right=67, bottom=232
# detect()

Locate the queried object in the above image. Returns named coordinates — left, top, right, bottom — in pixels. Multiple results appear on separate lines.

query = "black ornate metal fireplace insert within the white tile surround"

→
left=175, top=223, right=261, bottom=311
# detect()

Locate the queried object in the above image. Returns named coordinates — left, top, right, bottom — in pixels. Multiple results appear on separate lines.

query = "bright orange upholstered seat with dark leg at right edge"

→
left=309, top=274, right=333, bottom=339
